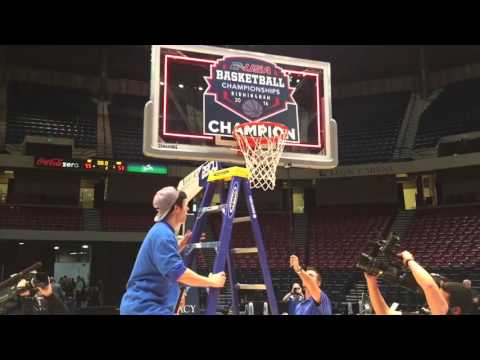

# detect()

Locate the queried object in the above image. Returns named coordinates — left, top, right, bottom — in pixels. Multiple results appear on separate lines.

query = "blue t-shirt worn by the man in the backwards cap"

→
left=120, top=222, right=187, bottom=315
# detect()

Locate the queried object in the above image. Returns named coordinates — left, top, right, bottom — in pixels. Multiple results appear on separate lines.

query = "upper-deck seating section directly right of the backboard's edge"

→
left=333, top=92, right=410, bottom=165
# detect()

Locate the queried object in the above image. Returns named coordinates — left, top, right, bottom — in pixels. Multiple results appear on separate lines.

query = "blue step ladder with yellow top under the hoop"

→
left=185, top=167, right=278, bottom=315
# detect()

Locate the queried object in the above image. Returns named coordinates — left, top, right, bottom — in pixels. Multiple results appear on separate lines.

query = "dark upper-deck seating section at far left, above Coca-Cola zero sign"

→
left=7, top=83, right=97, bottom=148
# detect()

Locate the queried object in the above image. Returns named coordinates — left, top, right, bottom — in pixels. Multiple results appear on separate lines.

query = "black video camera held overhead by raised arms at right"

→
left=357, top=233, right=421, bottom=293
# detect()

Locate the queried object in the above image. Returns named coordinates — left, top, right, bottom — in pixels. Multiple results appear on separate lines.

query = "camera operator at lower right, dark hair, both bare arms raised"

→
left=364, top=251, right=472, bottom=315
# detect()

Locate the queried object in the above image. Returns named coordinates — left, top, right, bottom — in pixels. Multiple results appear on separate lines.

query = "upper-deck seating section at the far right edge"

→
left=415, top=79, right=480, bottom=148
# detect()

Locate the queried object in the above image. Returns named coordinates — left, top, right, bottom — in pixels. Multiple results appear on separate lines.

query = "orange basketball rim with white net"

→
left=233, top=121, right=288, bottom=191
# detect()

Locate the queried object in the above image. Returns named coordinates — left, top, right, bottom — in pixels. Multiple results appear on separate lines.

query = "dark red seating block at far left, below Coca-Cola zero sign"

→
left=0, top=205, right=83, bottom=230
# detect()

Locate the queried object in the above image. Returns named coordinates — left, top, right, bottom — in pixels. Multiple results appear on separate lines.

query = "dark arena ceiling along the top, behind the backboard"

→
left=4, top=45, right=480, bottom=83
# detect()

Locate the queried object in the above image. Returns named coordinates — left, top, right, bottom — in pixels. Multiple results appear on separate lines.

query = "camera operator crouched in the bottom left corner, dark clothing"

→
left=5, top=279, right=68, bottom=315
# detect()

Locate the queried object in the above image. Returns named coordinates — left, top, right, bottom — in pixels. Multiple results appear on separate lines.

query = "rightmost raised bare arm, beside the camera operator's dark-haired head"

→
left=400, top=251, right=448, bottom=315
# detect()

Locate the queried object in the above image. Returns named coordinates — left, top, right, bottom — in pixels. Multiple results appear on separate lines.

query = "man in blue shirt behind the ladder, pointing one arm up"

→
left=290, top=255, right=332, bottom=315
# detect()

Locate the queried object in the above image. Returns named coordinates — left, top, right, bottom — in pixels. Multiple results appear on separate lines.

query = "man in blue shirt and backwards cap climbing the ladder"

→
left=120, top=186, right=225, bottom=315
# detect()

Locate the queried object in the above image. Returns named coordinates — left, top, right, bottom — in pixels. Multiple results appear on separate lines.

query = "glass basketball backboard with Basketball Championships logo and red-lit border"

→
left=143, top=45, right=338, bottom=169
